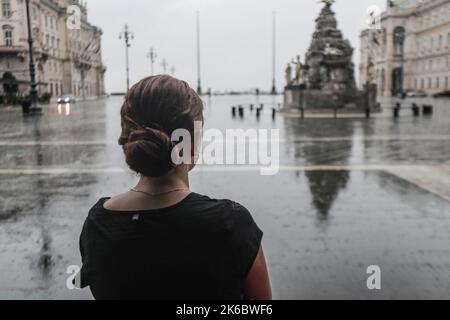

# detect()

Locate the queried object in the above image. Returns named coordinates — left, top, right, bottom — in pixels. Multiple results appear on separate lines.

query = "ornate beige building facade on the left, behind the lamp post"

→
left=0, top=0, right=106, bottom=99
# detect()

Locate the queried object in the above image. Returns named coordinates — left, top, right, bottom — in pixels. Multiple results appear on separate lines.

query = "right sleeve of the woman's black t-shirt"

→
left=233, top=204, right=263, bottom=279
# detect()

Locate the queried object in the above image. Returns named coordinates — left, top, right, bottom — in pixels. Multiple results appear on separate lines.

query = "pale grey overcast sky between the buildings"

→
left=88, top=0, right=385, bottom=92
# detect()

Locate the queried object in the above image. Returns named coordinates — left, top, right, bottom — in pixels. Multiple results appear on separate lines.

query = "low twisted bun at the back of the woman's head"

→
left=123, top=128, right=175, bottom=177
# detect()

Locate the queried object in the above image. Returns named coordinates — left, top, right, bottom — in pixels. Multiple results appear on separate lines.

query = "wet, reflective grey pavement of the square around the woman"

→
left=0, top=96, right=450, bottom=299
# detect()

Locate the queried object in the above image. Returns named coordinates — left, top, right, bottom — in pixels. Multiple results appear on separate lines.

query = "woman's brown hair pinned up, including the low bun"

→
left=119, top=75, right=203, bottom=177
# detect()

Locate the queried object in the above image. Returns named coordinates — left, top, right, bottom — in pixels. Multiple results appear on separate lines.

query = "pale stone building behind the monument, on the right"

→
left=359, top=0, right=450, bottom=97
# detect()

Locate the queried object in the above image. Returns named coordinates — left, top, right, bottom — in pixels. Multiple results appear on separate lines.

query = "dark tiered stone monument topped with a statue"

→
left=284, top=0, right=376, bottom=112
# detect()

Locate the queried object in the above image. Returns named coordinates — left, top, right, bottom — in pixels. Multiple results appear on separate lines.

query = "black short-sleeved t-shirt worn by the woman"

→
left=80, top=193, right=263, bottom=300
